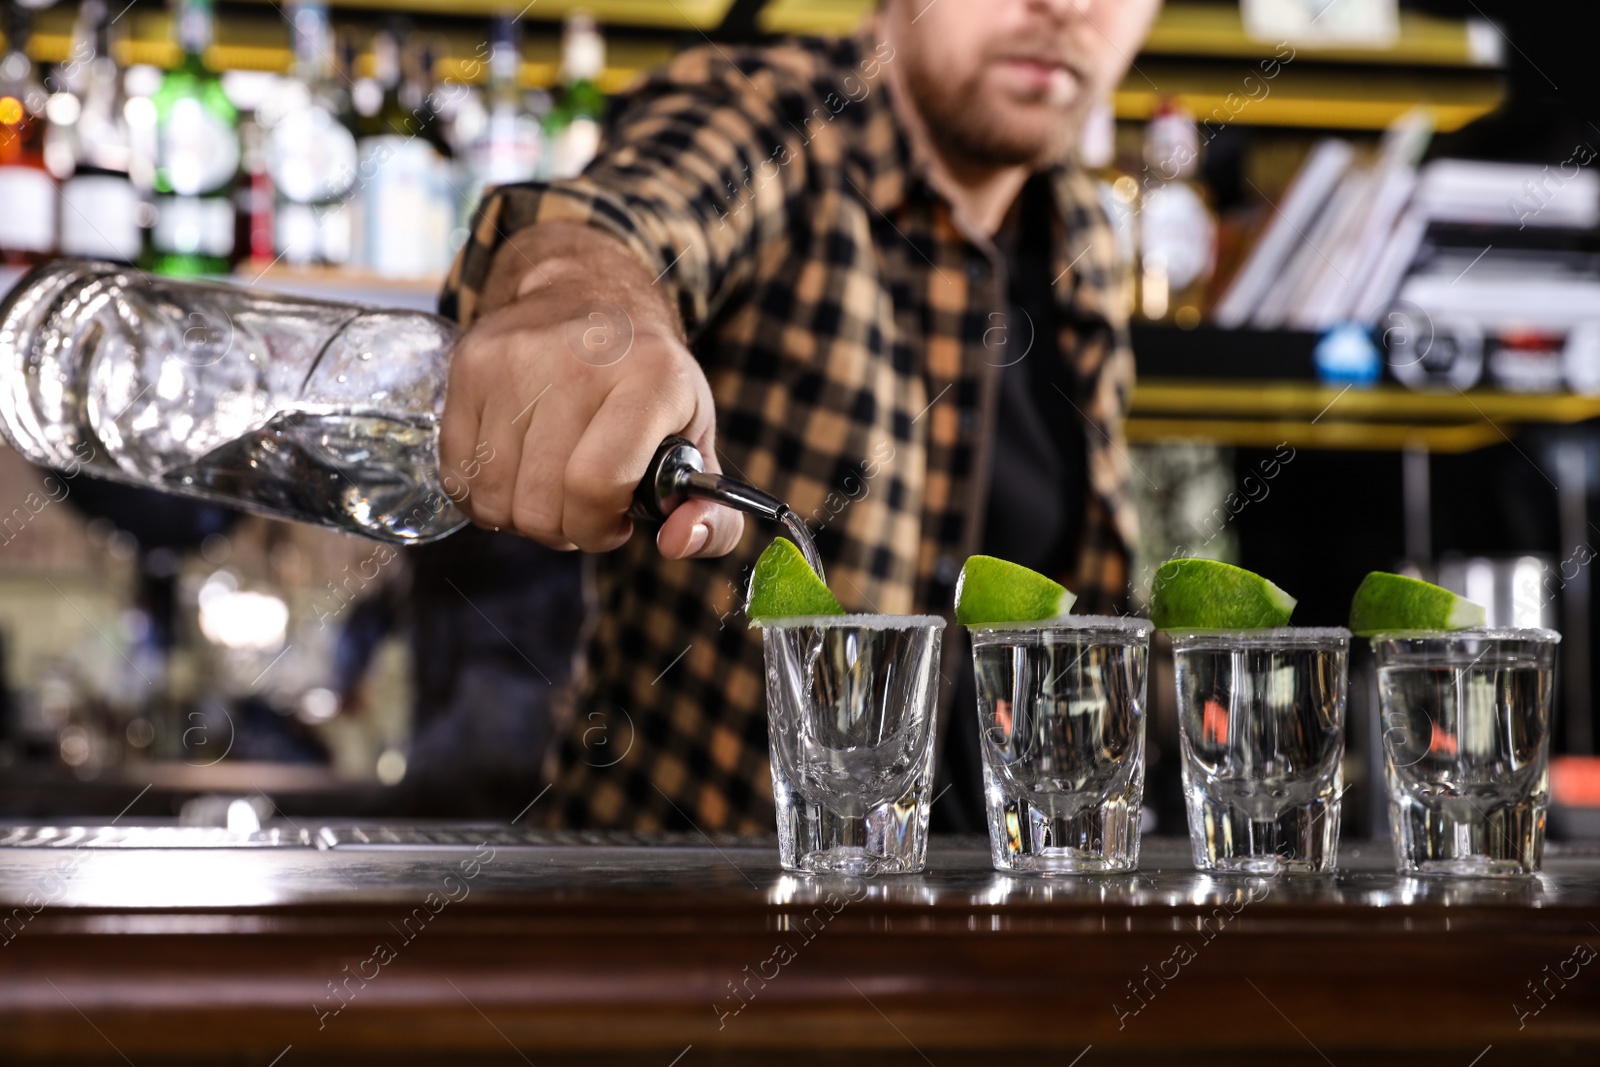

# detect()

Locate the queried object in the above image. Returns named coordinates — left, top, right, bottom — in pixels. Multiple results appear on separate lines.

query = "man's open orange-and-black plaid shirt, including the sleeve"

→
left=442, top=24, right=1134, bottom=832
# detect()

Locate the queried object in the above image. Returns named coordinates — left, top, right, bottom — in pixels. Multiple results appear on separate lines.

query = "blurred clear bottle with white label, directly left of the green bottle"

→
left=51, top=0, right=142, bottom=262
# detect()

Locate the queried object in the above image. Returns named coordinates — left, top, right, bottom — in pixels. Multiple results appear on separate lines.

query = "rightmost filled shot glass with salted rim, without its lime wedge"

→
left=1373, top=629, right=1562, bottom=877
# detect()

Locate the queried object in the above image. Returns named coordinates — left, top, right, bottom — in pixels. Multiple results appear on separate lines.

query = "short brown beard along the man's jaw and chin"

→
left=906, top=52, right=1082, bottom=166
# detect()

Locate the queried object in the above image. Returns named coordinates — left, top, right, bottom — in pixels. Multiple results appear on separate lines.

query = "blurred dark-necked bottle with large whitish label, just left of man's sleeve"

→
left=358, top=27, right=456, bottom=278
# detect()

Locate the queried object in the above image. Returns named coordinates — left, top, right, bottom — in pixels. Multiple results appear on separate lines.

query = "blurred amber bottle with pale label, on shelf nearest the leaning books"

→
left=1138, top=102, right=1216, bottom=328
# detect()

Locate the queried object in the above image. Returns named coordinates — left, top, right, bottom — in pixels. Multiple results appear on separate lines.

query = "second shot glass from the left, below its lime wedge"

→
left=973, top=616, right=1154, bottom=873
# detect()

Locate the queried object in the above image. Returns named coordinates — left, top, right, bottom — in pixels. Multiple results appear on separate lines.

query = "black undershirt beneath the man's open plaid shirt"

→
left=933, top=174, right=1088, bottom=833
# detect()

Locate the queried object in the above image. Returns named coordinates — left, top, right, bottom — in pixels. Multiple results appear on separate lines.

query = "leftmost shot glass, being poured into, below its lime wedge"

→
left=762, top=614, right=944, bottom=875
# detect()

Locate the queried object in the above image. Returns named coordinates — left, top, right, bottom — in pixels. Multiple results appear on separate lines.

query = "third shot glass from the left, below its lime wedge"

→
left=1173, top=627, right=1350, bottom=875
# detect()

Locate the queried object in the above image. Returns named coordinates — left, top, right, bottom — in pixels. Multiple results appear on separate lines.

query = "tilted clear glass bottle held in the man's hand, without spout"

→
left=0, top=259, right=467, bottom=544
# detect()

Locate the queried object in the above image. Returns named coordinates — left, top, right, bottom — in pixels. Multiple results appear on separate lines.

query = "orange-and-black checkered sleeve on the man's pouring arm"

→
left=440, top=48, right=805, bottom=338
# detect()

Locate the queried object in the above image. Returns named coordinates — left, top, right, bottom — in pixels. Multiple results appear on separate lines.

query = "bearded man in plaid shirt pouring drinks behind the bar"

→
left=440, top=0, right=1158, bottom=832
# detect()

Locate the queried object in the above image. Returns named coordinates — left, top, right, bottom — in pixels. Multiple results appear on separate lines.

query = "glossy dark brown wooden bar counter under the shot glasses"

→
left=0, top=825, right=1600, bottom=1067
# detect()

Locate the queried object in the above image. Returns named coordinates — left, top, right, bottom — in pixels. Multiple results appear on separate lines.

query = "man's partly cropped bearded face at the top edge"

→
left=886, top=0, right=1160, bottom=166
